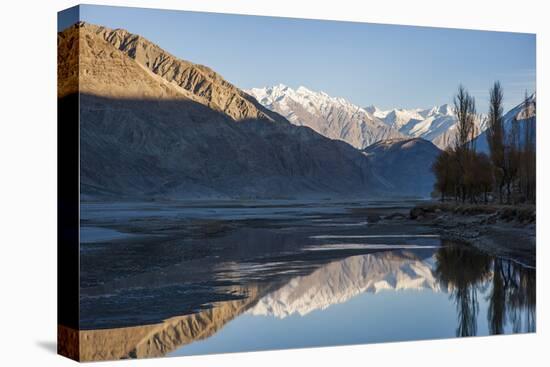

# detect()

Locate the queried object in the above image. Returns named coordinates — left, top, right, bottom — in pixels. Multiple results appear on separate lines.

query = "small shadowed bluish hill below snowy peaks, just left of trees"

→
left=363, top=138, right=441, bottom=196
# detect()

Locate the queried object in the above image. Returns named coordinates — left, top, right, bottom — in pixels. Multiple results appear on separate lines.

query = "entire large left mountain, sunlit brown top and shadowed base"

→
left=58, top=22, right=384, bottom=198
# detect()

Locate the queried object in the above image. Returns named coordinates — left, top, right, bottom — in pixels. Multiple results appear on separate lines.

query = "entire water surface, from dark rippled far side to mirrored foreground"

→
left=77, top=203, right=536, bottom=358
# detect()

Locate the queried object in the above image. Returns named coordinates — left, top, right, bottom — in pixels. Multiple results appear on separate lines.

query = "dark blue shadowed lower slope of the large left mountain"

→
left=60, top=94, right=382, bottom=198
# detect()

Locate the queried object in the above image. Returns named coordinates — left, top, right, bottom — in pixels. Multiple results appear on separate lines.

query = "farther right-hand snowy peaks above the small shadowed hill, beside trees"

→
left=365, top=104, right=487, bottom=149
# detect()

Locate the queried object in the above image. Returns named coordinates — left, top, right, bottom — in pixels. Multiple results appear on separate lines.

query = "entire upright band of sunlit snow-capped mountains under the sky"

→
left=246, top=84, right=486, bottom=149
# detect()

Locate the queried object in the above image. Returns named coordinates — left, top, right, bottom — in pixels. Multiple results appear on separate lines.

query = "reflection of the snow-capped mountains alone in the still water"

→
left=248, top=251, right=445, bottom=318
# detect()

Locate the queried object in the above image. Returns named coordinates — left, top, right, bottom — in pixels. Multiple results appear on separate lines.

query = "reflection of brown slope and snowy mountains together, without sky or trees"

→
left=74, top=250, right=447, bottom=361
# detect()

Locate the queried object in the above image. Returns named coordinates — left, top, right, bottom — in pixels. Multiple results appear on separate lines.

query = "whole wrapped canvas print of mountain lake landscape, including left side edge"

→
left=57, top=5, right=536, bottom=361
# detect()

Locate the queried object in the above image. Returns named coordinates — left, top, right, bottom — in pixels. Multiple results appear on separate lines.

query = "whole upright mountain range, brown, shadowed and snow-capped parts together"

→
left=58, top=22, right=540, bottom=200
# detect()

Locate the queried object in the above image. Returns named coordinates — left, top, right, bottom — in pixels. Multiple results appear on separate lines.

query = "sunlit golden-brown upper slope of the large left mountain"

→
left=59, top=22, right=284, bottom=121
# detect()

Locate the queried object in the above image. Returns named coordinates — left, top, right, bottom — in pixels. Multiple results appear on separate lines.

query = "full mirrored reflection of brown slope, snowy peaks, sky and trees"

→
left=76, top=243, right=536, bottom=360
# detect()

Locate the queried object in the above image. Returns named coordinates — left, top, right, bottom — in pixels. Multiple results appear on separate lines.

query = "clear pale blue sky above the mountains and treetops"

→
left=59, top=5, right=536, bottom=112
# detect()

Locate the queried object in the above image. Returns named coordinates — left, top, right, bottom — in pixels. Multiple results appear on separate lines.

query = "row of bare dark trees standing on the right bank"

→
left=432, top=82, right=536, bottom=204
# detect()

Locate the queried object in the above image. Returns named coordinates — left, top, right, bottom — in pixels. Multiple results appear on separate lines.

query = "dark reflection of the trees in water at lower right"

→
left=435, top=242, right=536, bottom=336
